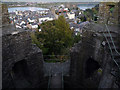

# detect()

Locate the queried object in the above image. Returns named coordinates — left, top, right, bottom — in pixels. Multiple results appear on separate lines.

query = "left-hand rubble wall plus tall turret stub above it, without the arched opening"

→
left=0, top=4, right=43, bottom=88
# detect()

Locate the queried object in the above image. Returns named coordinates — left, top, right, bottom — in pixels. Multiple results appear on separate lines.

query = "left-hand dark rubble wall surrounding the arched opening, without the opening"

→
left=2, top=28, right=43, bottom=88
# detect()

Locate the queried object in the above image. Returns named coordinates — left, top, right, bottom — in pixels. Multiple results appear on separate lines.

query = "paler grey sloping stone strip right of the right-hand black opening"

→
left=98, top=52, right=115, bottom=88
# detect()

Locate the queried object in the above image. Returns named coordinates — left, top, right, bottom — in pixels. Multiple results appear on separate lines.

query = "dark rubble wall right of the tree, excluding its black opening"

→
left=70, top=24, right=104, bottom=87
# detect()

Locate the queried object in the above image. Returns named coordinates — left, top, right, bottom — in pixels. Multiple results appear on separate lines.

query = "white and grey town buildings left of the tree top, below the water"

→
left=9, top=10, right=54, bottom=29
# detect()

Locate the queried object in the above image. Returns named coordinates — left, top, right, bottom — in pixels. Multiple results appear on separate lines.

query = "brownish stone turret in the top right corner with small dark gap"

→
left=99, top=2, right=120, bottom=25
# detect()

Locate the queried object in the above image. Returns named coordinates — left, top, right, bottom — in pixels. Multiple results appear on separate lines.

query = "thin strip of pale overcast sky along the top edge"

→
left=1, top=0, right=120, bottom=2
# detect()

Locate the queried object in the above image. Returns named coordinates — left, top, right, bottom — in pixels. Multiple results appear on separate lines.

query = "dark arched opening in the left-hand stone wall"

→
left=12, top=60, right=30, bottom=88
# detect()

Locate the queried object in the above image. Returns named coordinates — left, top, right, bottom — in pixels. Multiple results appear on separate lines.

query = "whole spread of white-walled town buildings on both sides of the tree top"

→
left=9, top=4, right=91, bottom=35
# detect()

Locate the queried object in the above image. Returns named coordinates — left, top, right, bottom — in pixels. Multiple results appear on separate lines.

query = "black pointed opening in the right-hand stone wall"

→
left=85, top=58, right=100, bottom=78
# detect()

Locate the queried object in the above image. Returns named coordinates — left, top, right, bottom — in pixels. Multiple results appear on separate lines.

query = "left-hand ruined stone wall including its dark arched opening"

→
left=2, top=26, right=43, bottom=88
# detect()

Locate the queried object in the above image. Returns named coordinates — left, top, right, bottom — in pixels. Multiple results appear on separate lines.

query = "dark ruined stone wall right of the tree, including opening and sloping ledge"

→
left=70, top=24, right=118, bottom=88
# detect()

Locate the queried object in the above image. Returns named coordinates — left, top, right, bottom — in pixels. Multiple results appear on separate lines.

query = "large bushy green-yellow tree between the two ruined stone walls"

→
left=33, top=16, right=73, bottom=55
